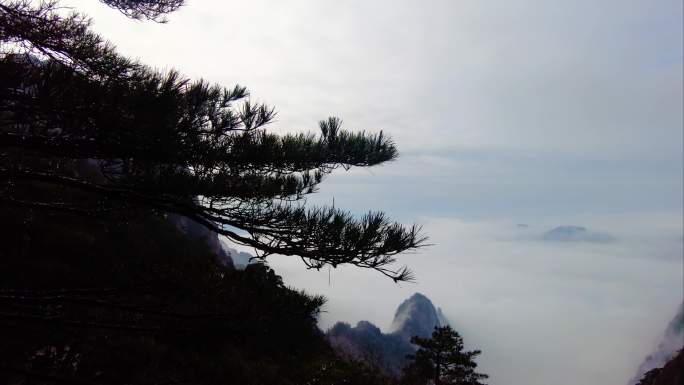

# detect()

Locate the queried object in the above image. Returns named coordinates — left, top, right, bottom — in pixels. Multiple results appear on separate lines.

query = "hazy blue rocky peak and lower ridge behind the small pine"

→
left=326, top=293, right=446, bottom=375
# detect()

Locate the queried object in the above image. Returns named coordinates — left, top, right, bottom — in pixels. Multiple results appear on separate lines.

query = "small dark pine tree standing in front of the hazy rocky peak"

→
left=404, top=325, right=488, bottom=385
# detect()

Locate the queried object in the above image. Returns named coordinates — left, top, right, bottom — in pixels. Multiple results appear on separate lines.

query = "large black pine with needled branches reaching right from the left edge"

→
left=0, top=0, right=425, bottom=281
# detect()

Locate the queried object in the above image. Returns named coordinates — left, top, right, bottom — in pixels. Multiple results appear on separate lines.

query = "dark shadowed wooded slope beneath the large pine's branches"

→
left=0, top=194, right=385, bottom=385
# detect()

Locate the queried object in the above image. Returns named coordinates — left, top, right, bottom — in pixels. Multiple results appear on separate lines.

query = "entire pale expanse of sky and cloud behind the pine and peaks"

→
left=65, top=0, right=684, bottom=385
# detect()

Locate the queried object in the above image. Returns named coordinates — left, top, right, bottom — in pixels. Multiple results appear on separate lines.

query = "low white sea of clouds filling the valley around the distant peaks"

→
left=264, top=215, right=684, bottom=385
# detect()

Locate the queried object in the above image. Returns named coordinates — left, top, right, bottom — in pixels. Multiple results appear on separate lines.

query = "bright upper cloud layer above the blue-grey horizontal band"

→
left=70, top=0, right=683, bottom=157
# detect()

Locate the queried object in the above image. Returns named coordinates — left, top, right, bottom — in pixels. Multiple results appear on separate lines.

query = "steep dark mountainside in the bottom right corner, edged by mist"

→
left=629, top=302, right=684, bottom=385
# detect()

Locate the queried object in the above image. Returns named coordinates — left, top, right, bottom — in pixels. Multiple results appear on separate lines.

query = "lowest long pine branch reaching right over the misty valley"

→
left=0, top=169, right=426, bottom=281
